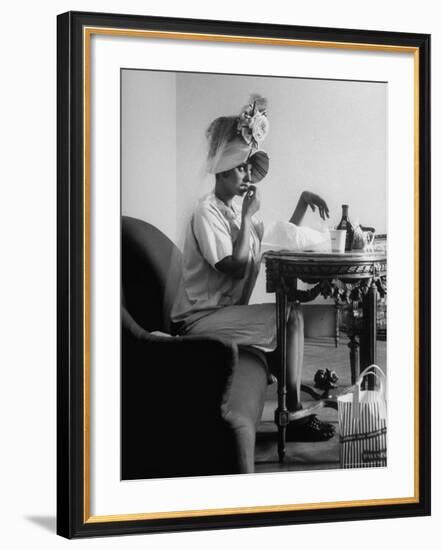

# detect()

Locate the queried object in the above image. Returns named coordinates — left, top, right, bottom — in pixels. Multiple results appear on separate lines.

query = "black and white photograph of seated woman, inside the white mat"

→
left=120, top=67, right=388, bottom=480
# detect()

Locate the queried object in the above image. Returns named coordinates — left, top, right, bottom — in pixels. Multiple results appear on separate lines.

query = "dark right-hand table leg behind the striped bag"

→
left=360, top=281, right=378, bottom=390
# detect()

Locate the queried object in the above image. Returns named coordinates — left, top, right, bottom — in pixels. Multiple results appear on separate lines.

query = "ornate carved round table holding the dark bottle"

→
left=264, top=251, right=387, bottom=462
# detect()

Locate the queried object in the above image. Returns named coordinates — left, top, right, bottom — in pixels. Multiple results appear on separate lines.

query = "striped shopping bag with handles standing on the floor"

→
left=338, top=365, right=387, bottom=468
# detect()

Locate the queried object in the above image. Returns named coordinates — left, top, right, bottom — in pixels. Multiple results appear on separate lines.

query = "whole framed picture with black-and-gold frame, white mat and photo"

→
left=57, top=12, right=431, bottom=538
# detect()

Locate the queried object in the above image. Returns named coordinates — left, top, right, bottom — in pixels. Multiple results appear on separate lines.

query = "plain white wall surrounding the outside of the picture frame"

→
left=0, top=0, right=442, bottom=550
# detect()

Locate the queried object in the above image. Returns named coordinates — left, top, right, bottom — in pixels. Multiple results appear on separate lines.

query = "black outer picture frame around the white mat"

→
left=57, top=12, right=431, bottom=538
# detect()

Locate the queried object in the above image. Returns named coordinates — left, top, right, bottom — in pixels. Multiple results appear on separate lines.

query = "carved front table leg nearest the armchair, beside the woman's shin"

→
left=275, top=290, right=289, bottom=463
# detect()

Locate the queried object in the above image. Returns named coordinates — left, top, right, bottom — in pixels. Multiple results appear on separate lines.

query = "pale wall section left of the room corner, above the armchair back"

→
left=121, top=69, right=176, bottom=236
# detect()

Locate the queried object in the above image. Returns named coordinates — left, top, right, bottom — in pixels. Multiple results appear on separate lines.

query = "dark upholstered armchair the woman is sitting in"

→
left=121, top=216, right=268, bottom=479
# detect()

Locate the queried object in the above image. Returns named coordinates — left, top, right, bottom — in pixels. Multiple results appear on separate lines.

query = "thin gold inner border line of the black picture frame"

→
left=83, top=27, right=420, bottom=524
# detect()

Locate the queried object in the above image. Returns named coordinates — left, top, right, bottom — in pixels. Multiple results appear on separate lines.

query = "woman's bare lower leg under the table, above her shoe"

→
left=287, top=303, right=304, bottom=411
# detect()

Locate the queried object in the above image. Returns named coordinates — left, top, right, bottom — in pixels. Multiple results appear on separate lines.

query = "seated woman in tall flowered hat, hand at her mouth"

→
left=172, top=96, right=334, bottom=441
